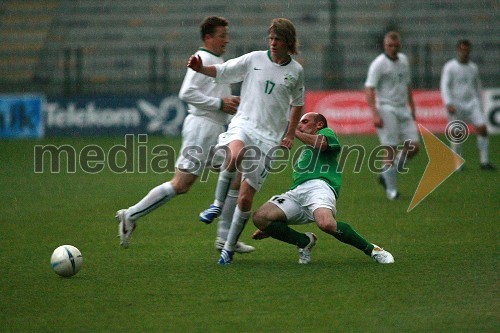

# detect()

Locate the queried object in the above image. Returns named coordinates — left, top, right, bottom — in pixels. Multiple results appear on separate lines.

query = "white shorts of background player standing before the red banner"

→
left=377, top=104, right=418, bottom=147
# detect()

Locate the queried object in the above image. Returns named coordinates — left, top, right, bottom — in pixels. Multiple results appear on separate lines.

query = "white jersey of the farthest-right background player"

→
left=440, top=59, right=481, bottom=110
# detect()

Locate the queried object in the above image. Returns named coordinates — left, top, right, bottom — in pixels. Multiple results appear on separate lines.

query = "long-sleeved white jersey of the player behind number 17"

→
left=179, top=48, right=231, bottom=125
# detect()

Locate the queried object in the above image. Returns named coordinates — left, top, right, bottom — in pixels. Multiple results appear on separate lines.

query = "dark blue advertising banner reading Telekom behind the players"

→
left=45, top=96, right=187, bottom=136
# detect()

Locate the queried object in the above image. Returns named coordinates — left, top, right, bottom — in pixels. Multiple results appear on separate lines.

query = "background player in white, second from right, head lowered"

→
left=365, top=31, right=419, bottom=200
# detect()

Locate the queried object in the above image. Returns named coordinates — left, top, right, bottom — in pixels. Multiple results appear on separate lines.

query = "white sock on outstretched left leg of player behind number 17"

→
left=126, top=182, right=177, bottom=221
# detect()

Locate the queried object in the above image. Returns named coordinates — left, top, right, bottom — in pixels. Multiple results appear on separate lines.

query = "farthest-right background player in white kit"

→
left=440, top=39, right=495, bottom=170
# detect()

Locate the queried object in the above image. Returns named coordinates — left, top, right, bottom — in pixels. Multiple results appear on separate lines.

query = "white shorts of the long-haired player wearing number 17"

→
left=217, top=125, right=277, bottom=192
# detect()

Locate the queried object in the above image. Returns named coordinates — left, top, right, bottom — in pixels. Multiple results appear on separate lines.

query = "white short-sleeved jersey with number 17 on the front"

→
left=216, top=51, right=304, bottom=144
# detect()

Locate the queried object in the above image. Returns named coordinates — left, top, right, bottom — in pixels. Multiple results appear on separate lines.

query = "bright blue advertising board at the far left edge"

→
left=0, top=95, right=44, bottom=138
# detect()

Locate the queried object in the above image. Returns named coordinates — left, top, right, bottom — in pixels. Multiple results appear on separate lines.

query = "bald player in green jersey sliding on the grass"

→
left=253, top=113, right=394, bottom=264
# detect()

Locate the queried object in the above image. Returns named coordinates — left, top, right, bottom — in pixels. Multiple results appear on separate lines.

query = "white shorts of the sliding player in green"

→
left=268, top=179, right=337, bottom=224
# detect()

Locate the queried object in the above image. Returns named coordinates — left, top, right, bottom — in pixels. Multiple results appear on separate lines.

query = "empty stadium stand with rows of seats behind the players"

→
left=0, top=0, right=500, bottom=95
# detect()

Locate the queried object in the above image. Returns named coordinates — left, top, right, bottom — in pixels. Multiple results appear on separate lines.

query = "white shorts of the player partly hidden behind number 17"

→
left=175, top=114, right=225, bottom=176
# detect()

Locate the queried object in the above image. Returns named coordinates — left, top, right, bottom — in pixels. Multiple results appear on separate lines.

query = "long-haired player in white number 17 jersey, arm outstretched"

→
left=188, top=18, right=304, bottom=265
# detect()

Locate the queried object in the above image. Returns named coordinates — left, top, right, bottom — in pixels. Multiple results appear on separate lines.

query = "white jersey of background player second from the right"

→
left=365, top=53, right=411, bottom=107
